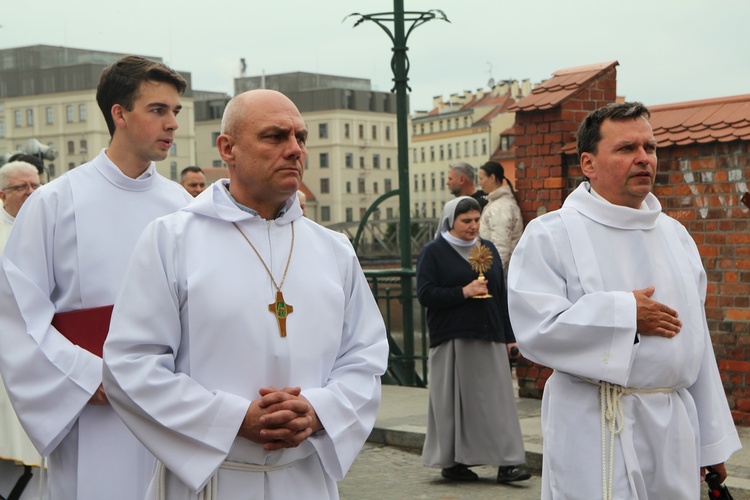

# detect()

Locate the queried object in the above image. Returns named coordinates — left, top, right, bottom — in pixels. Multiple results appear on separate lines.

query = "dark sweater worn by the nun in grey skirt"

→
left=417, top=236, right=516, bottom=347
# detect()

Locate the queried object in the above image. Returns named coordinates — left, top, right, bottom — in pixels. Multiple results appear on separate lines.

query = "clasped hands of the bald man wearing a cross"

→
left=238, top=387, right=322, bottom=451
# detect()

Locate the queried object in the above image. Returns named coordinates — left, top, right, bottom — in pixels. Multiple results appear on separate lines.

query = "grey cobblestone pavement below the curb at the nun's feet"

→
left=339, top=443, right=541, bottom=500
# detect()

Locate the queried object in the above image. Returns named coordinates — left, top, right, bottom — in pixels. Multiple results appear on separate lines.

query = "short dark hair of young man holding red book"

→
left=96, top=56, right=187, bottom=136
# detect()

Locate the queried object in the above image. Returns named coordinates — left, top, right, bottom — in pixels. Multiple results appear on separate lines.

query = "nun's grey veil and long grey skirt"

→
left=422, top=197, right=526, bottom=468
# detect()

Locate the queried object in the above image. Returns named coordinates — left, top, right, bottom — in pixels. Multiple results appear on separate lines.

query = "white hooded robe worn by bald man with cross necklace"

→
left=104, top=181, right=388, bottom=500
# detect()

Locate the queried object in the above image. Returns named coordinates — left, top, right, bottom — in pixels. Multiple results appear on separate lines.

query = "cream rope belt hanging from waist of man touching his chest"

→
left=576, top=377, right=675, bottom=500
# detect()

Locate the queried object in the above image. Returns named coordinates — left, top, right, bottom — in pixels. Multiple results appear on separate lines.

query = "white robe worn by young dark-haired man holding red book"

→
left=0, top=151, right=192, bottom=500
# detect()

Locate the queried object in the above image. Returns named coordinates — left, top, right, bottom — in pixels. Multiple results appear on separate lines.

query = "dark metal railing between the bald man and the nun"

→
left=364, top=269, right=429, bottom=387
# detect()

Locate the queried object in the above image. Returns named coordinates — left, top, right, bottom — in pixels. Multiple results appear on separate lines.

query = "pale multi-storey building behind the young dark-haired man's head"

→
left=0, top=45, right=195, bottom=180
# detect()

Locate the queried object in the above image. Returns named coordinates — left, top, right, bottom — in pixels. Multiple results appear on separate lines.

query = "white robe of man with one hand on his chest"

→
left=508, top=183, right=741, bottom=500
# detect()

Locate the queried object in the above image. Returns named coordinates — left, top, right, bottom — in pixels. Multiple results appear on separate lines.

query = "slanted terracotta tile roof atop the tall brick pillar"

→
left=508, top=61, right=619, bottom=112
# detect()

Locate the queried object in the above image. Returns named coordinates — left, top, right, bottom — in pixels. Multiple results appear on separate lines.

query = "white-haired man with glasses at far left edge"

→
left=0, top=161, right=39, bottom=255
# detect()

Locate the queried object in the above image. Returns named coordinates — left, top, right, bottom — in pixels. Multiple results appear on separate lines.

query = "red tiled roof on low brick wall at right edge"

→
left=649, top=94, right=750, bottom=148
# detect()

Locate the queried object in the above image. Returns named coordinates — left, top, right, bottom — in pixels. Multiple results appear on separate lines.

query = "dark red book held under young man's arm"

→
left=52, top=306, right=114, bottom=358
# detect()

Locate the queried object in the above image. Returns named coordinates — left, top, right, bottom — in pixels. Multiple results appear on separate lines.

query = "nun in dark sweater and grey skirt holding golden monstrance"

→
left=417, top=196, right=530, bottom=483
